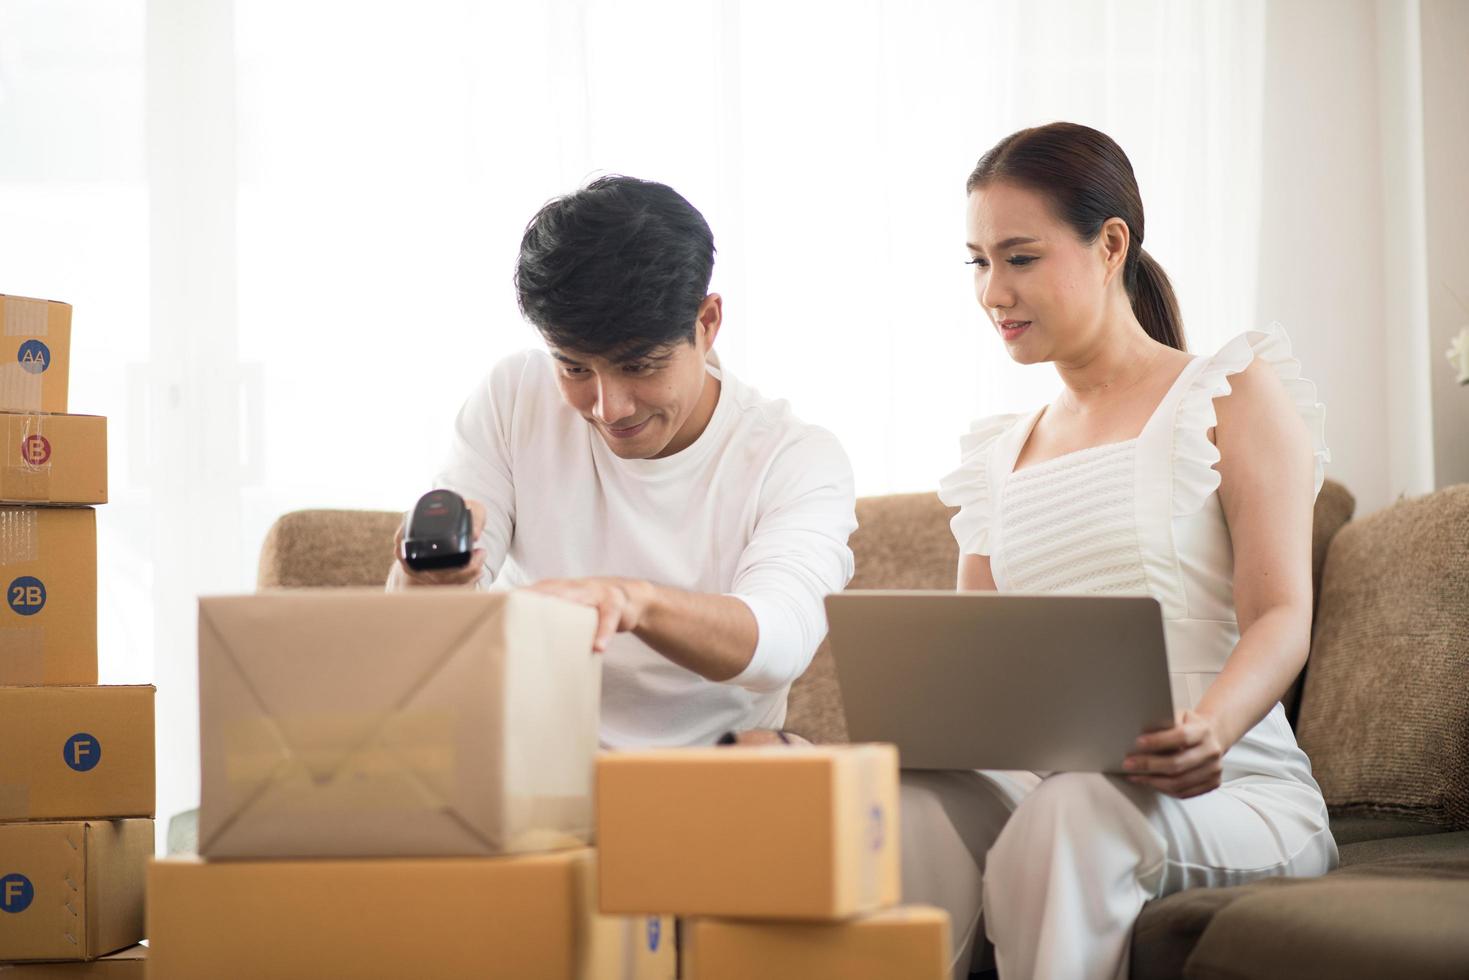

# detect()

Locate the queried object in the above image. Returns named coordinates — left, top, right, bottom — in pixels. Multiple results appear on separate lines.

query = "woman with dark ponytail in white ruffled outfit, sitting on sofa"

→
left=903, top=123, right=1337, bottom=979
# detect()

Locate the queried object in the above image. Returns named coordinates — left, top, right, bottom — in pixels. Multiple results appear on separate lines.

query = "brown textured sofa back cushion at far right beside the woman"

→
left=1297, top=485, right=1469, bottom=827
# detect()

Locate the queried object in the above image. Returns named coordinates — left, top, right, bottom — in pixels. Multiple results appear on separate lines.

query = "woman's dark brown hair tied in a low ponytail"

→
left=964, top=122, right=1187, bottom=350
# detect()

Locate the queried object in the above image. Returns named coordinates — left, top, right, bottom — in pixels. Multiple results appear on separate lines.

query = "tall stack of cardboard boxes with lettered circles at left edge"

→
left=0, top=295, right=154, bottom=977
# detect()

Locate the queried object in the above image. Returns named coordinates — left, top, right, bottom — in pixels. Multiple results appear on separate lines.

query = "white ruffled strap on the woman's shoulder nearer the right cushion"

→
left=1174, top=323, right=1331, bottom=517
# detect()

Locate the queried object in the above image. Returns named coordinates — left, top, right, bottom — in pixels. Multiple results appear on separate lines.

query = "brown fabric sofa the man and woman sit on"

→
left=259, top=480, right=1469, bottom=980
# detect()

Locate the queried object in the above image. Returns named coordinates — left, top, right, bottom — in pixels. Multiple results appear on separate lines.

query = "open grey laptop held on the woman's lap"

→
left=826, top=591, right=1174, bottom=773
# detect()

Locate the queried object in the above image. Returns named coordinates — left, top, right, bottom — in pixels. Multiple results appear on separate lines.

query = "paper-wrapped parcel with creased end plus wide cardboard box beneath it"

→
left=148, top=589, right=676, bottom=980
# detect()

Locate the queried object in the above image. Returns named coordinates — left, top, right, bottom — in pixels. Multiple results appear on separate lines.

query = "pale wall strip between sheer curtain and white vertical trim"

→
left=1256, top=0, right=1397, bottom=514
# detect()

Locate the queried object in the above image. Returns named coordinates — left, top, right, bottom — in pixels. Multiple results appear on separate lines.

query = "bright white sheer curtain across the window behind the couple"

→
left=0, top=0, right=1263, bottom=846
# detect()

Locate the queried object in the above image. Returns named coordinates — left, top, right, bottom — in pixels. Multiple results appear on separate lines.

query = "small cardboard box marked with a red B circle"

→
left=0, top=411, right=107, bottom=504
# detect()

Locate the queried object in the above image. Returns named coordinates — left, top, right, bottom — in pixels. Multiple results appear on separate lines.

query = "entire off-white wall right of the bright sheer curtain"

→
left=1257, top=0, right=1469, bottom=516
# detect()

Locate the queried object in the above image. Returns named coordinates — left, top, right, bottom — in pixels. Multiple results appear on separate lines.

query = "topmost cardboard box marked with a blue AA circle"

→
left=0, top=295, right=72, bottom=411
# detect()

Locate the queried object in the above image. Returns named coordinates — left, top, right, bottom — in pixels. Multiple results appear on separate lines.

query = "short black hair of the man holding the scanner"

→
left=516, top=175, right=714, bottom=360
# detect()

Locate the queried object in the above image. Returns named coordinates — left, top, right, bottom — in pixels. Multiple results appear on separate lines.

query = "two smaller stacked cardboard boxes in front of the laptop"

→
left=596, top=745, right=949, bottom=980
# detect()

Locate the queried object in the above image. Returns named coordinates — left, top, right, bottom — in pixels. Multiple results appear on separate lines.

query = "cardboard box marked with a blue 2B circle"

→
left=0, top=507, right=97, bottom=687
